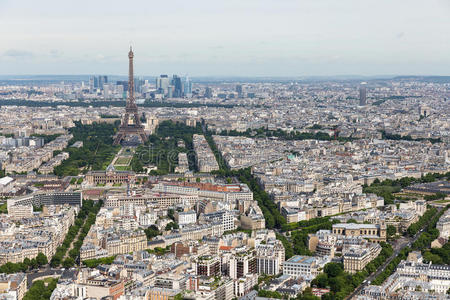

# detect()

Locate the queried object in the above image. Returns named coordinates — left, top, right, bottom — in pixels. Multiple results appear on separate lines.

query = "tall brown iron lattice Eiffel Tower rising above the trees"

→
left=114, top=46, right=147, bottom=145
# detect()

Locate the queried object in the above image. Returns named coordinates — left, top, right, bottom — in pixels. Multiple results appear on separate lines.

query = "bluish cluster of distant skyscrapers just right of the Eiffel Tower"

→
left=156, top=75, right=192, bottom=98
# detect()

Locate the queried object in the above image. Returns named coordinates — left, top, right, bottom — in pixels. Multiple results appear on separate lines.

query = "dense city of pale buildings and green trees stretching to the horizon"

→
left=0, top=73, right=450, bottom=300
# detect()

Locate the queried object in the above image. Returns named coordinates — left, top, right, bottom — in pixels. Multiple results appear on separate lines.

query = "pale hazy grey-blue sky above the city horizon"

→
left=0, top=0, right=450, bottom=76
